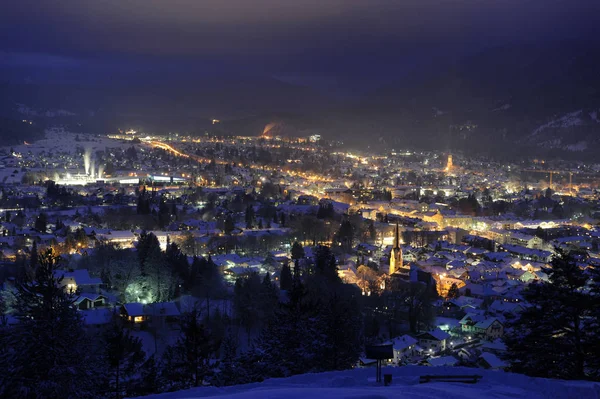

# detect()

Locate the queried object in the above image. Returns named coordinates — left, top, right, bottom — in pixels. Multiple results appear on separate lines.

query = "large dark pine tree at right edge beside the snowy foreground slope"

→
left=505, top=248, right=597, bottom=379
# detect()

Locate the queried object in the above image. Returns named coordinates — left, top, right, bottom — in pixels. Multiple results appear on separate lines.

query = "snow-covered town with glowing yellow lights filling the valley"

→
left=0, top=131, right=600, bottom=368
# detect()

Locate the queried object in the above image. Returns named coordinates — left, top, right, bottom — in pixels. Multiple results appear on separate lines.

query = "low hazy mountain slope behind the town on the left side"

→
left=0, top=77, right=334, bottom=137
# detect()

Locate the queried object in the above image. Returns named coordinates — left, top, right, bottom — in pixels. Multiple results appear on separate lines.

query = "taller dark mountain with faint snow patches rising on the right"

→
left=324, top=42, right=600, bottom=158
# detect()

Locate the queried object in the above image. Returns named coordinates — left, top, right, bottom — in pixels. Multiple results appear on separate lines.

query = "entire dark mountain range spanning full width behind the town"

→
left=0, top=42, right=600, bottom=159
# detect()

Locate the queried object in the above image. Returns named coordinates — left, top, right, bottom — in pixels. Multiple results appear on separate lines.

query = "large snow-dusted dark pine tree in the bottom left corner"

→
left=0, top=249, right=97, bottom=398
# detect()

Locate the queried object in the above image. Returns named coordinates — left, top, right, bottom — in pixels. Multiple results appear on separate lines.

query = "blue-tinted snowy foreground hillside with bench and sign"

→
left=136, top=366, right=600, bottom=399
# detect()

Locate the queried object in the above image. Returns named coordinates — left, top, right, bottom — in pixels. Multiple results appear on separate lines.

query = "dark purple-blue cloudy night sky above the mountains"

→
left=0, top=0, right=600, bottom=94
